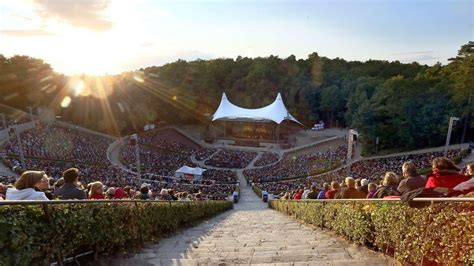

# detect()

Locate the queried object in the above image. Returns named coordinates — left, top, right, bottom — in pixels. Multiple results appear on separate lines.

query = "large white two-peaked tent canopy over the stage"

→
left=212, top=93, right=301, bottom=124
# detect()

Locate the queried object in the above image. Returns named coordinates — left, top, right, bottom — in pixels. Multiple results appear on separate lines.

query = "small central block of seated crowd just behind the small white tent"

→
left=204, top=150, right=257, bottom=169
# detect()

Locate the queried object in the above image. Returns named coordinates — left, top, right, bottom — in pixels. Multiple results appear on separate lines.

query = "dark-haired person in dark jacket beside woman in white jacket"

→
left=53, top=168, right=87, bottom=200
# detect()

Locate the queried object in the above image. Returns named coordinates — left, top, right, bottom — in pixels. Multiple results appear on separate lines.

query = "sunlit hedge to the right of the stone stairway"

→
left=270, top=200, right=474, bottom=265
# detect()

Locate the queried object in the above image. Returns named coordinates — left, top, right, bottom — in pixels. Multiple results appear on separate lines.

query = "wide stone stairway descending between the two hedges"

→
left=111, top=173, right=394, bottom=266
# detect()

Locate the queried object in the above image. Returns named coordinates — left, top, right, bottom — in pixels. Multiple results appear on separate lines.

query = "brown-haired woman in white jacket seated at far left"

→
left=6, top=171, right=49, bottom=200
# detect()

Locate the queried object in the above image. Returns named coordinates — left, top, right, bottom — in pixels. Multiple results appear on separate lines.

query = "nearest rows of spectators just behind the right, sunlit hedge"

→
left=279, top=157, right=474, bottom=200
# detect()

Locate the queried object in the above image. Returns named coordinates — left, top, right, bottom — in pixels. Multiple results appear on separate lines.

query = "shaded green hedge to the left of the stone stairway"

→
left=0, top=201, right=233, bottom=265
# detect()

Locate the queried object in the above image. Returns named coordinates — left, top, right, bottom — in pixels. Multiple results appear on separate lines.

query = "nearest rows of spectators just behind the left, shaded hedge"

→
left=0, top=168, right=235, bottom=201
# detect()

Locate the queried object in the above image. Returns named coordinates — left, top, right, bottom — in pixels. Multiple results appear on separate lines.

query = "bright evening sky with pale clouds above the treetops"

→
left=0, top=0, right=474, bottom=75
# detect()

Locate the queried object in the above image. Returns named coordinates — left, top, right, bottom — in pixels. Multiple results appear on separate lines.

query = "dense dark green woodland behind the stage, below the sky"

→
left=0, top=42, right=474, bottom=153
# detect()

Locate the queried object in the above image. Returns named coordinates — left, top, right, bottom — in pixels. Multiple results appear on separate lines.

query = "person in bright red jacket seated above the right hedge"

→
left=425, top=157, right=469, bottom=189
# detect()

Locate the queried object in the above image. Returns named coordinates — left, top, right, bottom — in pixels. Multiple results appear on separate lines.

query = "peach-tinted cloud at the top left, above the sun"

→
left=34, top=0, right=113, bottom=31
